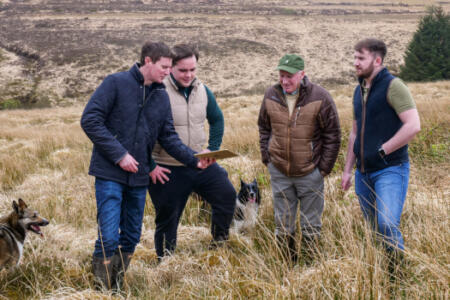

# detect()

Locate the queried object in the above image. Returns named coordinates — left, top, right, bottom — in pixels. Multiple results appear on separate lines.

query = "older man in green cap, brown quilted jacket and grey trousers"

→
left=258, top=54, right=341, bottom=264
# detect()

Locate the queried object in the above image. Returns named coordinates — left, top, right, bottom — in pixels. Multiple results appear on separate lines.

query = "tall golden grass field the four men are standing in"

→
left=0, top=81, right=450, bottom=299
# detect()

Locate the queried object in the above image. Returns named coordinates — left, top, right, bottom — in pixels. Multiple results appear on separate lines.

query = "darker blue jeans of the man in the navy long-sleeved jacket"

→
left=94, top=178, right=147, bottom=257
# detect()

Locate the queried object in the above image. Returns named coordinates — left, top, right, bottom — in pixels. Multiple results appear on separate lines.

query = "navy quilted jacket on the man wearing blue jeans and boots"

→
left=81, top=64, right=198, bottom=187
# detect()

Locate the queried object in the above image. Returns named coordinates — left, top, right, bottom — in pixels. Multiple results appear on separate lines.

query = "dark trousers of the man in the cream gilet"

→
left=148, top=163, right=236, bottom=257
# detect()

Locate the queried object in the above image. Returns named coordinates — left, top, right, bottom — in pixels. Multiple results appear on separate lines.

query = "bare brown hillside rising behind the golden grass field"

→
left=0, top=0, right=450, bottom=107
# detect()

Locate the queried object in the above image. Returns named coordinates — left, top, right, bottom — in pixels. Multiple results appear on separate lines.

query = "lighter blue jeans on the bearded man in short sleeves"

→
left=355, top=162, right=409, bottom=251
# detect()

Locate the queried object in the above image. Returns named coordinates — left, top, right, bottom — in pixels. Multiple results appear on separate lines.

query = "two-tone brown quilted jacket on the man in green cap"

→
left=258, top=76, right=341, bottom=176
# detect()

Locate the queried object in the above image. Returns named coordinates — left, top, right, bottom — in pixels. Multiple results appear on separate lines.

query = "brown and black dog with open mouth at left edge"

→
left=0, top=199, right=48, bottom=269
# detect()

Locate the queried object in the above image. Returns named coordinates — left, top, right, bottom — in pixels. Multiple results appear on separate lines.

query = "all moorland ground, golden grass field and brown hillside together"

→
left=0, top=0, right=450, bottom=299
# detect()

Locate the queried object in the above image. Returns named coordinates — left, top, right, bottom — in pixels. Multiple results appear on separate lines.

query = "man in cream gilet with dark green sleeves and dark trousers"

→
left=149, top=44, right=236, bottom=259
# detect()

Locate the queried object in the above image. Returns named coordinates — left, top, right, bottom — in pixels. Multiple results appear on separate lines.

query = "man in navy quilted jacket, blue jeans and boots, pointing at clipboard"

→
left=81, top=42, right=210, bottom=289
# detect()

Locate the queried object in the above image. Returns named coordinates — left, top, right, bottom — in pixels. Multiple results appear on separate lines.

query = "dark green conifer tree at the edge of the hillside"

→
left=400, top=6, right=450, bottom=81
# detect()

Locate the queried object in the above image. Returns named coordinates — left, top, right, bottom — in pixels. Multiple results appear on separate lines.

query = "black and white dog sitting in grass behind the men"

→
left=233, top=179, right=261, bottom=232
